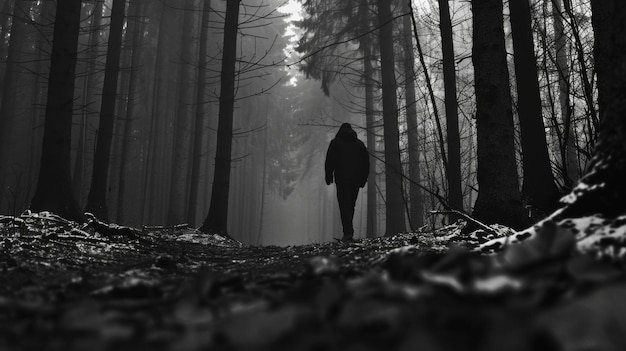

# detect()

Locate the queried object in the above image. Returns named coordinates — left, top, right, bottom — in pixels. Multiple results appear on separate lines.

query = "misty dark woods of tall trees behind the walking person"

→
left=0, top=0, right=625, bottom=244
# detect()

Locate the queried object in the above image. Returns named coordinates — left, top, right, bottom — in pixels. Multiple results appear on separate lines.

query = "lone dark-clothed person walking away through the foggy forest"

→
left=324, top=123, right=370, bottom=242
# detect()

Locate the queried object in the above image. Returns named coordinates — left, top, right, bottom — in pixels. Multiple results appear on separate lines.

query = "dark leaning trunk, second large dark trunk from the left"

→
left=85, top=0, right=126, bottom=221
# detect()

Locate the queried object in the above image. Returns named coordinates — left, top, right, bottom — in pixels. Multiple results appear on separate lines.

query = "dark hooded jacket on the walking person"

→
left=325, top=123, right=370, bottom=188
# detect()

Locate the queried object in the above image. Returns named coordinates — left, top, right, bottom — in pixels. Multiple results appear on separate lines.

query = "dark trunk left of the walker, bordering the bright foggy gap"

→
left=200, top=0, right=241, bottom=235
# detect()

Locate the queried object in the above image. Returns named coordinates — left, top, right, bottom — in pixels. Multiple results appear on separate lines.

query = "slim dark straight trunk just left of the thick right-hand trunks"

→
left=439, top=0, right=463, bottom=222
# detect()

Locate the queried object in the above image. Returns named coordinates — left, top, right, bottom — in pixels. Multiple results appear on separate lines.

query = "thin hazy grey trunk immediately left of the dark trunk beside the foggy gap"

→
left=187, top=0, right=211, bottom=226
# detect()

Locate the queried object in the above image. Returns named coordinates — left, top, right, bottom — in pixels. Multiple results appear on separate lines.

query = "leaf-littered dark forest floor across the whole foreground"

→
left=0, top=213, right=626, bottom=351
